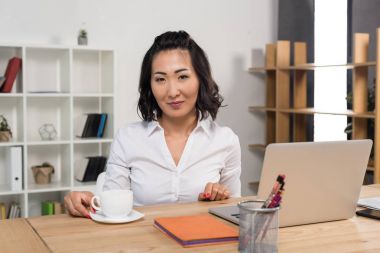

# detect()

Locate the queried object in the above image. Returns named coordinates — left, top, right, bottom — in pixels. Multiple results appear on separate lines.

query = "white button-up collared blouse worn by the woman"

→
left=103, top=119, right=241, bottom=206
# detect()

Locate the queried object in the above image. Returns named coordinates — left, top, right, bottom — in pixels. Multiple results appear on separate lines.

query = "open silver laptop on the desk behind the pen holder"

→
left=209, top=140, right=372, bottom=227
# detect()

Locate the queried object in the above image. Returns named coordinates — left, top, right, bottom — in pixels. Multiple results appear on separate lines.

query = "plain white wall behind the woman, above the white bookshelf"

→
left=0, top=0, right=277, bottom=194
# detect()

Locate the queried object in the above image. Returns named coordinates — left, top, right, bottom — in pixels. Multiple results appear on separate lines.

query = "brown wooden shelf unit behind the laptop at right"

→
left=249, top=28, right=380, bottom=183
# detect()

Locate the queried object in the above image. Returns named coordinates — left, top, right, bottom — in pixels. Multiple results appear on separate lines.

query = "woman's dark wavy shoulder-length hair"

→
left=137, top=31, right=223, bottom=121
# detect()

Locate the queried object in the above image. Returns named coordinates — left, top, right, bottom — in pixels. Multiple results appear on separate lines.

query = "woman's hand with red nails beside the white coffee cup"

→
left=65, top=192, right=94, bottom=218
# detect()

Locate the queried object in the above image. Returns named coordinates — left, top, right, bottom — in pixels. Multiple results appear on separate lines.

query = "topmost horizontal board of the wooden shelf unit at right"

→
left=249, top=61, right=376, bottom=73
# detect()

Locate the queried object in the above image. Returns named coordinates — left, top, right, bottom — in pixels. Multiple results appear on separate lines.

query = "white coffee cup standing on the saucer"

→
left=91, top=190, right=133, bottom=219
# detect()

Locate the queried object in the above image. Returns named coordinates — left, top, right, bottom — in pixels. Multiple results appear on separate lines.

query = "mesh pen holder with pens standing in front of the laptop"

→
left=238, top=175, right=285, bottom=253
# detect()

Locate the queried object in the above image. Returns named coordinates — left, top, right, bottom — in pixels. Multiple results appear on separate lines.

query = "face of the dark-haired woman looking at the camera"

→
left=150, top=49, right=199, bottom=121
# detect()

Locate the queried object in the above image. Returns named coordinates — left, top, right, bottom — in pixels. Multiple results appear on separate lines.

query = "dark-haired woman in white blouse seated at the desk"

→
left=65, top=31, right=241, bottom=217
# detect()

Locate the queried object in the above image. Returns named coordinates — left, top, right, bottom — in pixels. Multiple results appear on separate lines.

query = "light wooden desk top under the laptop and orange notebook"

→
left=0, top=186, right=380, bottom=253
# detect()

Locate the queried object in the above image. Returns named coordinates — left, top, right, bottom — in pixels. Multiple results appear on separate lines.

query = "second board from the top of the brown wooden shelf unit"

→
left=249, top=106, right=375, bottom=119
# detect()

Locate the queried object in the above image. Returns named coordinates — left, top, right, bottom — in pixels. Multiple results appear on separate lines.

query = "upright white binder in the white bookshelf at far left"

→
left=5, top=146, right=23, bottom=191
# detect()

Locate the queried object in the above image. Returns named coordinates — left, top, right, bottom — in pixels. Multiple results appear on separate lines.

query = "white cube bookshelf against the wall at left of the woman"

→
left=0, top=44, right=116, bottom=217
